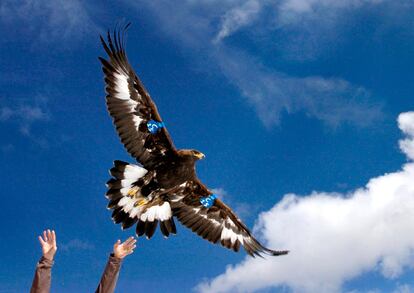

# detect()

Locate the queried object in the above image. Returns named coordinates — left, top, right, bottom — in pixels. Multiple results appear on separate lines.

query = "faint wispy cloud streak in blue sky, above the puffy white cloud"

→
left=217, top=46, right=382, bottom=127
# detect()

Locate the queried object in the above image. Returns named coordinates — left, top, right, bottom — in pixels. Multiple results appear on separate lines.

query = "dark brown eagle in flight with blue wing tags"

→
left=99, top=25, right=288, bottom=257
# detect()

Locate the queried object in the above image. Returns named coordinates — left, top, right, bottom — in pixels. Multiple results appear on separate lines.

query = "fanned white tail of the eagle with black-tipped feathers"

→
left=106, top=161, right=176, bottom=239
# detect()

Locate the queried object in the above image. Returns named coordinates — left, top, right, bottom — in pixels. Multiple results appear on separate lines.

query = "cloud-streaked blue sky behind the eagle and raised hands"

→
left=0, top=0, right=414, bottom=292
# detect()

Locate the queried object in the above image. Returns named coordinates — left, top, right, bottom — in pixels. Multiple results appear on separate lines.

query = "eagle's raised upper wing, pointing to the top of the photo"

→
left=99, top=26, right=177, bottom=169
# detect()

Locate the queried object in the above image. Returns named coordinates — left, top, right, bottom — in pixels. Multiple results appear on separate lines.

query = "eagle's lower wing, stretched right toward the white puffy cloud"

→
left=171, top=180, right=288, bottom=257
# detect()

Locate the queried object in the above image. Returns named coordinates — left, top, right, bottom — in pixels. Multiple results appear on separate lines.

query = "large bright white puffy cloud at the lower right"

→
left=197, top=112, right=414, bottom=293
